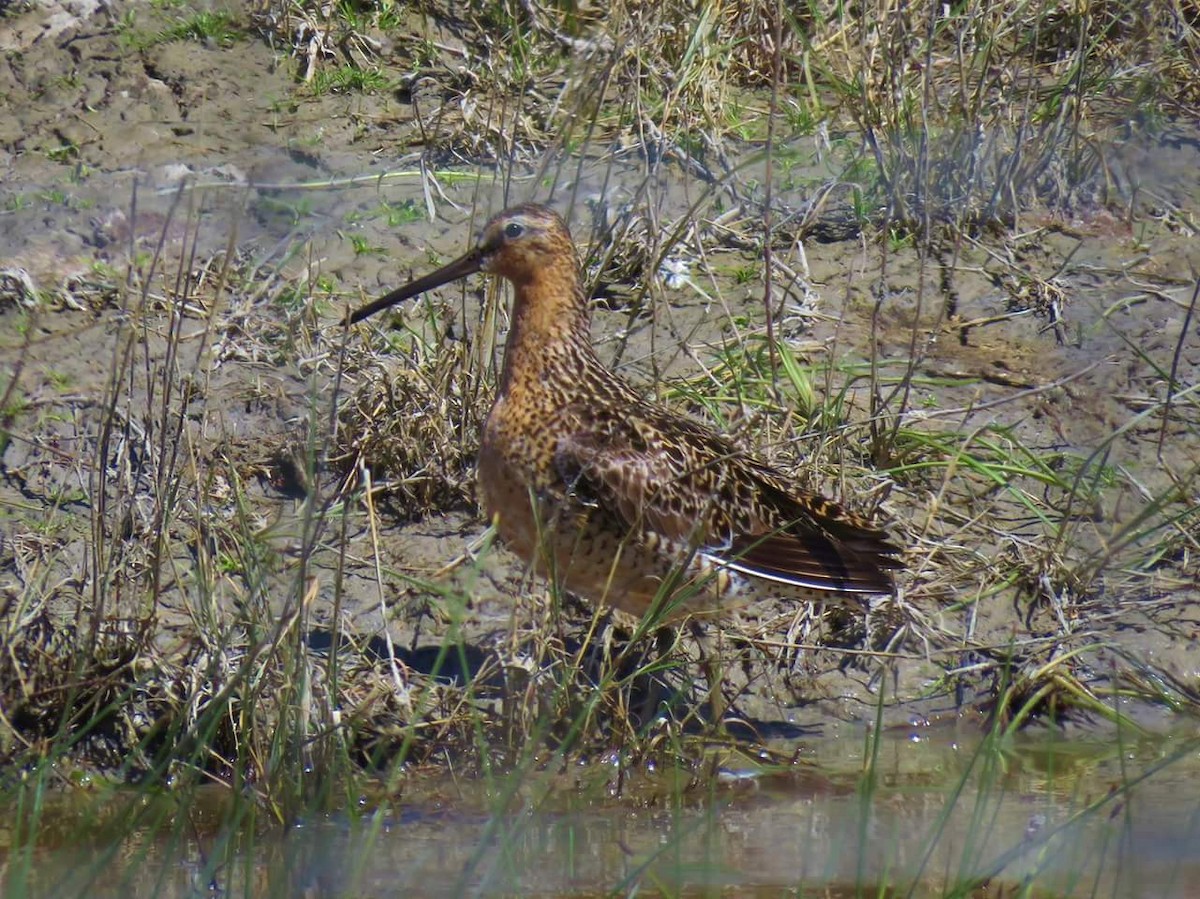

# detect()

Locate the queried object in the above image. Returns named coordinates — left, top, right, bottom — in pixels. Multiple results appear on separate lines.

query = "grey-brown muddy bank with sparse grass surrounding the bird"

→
left=0, top=4, right=1200, bottom=777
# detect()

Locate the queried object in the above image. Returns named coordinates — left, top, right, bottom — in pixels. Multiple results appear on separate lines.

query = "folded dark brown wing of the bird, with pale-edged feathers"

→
left=554, top=406, right=900, bottom=593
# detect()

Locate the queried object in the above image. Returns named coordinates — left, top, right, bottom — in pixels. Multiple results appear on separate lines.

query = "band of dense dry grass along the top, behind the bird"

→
left=258, top=0, right=1200, bottom=241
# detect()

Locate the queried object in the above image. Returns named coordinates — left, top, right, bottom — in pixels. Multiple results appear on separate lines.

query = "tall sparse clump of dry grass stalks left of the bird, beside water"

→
left=0, top=190, right=384, bottom=803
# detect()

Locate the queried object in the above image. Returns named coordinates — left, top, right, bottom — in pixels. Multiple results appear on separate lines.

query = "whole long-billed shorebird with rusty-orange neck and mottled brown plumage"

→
left=350, top=205, right=900, bottom=617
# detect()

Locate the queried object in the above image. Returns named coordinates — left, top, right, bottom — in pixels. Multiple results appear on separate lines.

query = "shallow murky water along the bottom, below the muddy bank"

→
left=14, top=732, right=1200, bottom=897
